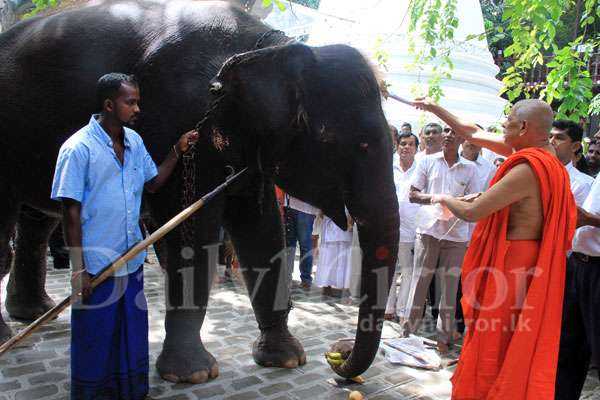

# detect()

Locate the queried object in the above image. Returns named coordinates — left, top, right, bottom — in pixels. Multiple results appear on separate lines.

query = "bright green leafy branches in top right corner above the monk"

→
left=502, top=0, right=600, bottom=122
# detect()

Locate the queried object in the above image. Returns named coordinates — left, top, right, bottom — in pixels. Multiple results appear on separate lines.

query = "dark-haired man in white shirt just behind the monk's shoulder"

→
left=550, top=120, right=594, bottom=207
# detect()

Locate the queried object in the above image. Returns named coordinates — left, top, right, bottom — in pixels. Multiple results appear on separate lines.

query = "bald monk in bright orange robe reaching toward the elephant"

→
left=414, top=99, right=577, bottom=400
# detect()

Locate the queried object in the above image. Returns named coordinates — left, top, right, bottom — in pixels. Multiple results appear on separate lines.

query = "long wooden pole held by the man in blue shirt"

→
left=0, top=168, right=248, bottom=357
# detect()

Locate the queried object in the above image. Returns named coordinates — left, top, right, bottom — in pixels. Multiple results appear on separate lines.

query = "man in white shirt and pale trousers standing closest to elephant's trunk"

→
left=384, top=132, right=420, bottom=323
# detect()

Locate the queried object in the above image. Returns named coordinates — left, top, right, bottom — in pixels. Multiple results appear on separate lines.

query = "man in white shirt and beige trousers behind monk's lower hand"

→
left=404, top=130, right=479, bottom=353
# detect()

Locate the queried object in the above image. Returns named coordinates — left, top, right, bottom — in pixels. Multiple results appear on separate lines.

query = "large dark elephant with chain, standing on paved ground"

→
left=0, top=0, right=399, bottom=383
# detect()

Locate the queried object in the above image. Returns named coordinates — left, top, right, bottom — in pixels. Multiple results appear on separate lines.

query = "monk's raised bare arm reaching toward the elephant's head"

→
left=413, top=98, right=513, bottom=157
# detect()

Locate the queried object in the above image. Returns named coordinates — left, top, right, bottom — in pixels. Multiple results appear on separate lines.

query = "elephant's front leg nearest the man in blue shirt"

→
left=156, top=211, right=222, bottom=383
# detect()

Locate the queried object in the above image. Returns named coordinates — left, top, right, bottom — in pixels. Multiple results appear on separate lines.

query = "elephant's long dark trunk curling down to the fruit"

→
left=335, top=164, right=399, bottom=378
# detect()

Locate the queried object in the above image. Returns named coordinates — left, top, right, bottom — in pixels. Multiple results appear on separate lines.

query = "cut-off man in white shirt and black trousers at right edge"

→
left=555, top=178, right=600, bottom=400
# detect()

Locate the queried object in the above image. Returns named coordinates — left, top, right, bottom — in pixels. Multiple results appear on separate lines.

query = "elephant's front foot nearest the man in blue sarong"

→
left=156, top=344, right=219, bottom=383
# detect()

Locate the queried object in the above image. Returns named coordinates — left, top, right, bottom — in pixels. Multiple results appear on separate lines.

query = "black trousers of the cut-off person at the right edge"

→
left=555, top=254, right=600, bottom=400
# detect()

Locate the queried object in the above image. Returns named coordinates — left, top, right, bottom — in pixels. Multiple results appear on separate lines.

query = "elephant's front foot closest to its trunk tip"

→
left=252, top=326, right=306, bottom=368
